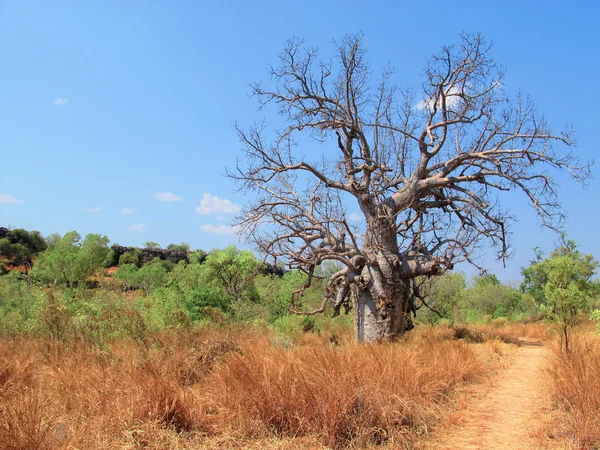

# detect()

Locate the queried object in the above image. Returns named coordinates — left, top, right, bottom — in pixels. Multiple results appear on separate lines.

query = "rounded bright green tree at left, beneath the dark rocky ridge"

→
left=32, top=231, right=110, bottom=286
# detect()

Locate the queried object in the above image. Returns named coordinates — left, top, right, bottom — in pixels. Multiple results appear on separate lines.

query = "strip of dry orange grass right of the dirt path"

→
left=550, top=335, right=600, bottom=449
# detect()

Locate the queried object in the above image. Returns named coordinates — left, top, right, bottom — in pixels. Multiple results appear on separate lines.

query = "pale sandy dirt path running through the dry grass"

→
left=426, top=343, right=551, bottom=450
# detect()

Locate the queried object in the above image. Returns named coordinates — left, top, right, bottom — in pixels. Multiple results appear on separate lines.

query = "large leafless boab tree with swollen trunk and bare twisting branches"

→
left=229, top=35, right=589, bottom=341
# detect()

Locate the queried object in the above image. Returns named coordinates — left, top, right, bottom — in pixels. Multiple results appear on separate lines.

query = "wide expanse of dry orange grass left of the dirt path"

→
left=0, top=329, right=516, bottom=449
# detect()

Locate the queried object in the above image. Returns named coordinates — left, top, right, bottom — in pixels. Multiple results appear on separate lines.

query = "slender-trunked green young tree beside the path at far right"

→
left=523, top=241, right=598, bottom=352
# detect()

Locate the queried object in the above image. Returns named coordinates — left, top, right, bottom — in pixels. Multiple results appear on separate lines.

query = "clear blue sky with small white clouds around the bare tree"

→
left=0, top=0, right=600, bottom=281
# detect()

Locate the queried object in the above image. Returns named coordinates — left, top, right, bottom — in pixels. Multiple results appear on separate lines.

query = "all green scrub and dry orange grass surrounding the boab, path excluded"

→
left=0, top=230, right=600, bottom=449
